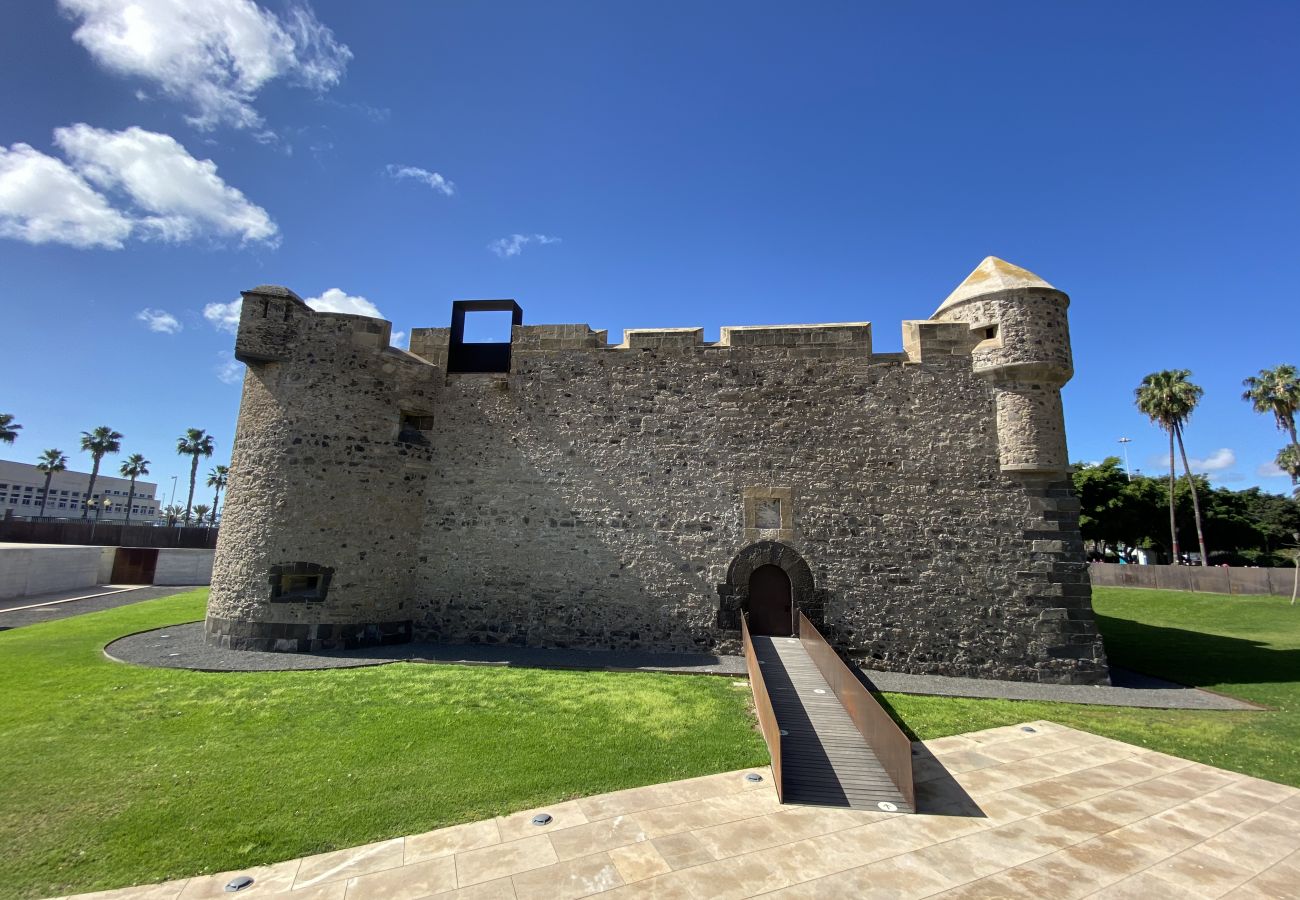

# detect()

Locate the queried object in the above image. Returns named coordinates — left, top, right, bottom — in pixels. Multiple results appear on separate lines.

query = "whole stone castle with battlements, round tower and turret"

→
left=205, top=258, right=1108, bottom=683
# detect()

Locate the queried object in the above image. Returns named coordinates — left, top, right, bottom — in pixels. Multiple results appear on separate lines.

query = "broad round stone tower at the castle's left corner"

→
left=205, top=285, right=438, bottom=650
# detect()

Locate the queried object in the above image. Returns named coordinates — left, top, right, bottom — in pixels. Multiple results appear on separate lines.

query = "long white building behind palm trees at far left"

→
left=0, top=458, right=161, bottom=525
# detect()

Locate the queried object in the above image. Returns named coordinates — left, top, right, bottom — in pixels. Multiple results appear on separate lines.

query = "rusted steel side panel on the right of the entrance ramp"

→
left=790, top=613, right=917, bottom=809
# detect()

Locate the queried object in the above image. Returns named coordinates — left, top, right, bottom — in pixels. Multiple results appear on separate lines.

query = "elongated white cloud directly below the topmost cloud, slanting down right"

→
left=55, top=124, right=280, bottom=245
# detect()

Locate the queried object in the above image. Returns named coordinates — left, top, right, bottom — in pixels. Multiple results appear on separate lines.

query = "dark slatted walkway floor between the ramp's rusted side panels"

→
left=751, top=635, right=914, bottom=813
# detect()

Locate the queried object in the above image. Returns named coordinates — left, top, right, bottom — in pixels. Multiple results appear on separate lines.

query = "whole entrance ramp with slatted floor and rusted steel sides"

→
left=745, top=615, right=915, bottom=813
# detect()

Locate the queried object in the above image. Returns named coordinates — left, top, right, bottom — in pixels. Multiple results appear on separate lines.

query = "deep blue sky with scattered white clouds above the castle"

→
left=0, top=0, right=1300, bottom=497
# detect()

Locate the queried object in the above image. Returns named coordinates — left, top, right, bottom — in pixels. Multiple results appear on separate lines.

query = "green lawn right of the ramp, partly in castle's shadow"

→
left=883, top=588, right=1300, bottom=787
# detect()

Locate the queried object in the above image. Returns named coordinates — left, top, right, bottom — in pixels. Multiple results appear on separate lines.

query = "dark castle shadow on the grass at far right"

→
left=1097, top=613, right=1300, bottom=687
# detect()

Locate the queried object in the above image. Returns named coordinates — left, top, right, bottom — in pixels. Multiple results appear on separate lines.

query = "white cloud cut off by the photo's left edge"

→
left=0, top=143, right=131, bottom=250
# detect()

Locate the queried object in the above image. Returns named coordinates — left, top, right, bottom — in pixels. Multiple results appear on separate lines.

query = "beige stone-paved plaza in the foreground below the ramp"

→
left=53, top=722, right=1300, bottom=900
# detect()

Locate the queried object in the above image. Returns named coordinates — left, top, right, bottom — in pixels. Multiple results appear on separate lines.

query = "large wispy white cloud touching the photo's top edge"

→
left=59, top=0, right=352, bottom=130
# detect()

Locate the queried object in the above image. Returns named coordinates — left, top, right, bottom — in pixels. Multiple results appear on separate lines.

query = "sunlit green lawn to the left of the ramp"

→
left=0, top=590, right=767, bottom=896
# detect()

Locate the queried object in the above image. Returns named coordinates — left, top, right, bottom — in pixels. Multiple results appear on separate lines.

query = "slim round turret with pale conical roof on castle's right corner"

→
left=931, top=256, right=1074, bottom=475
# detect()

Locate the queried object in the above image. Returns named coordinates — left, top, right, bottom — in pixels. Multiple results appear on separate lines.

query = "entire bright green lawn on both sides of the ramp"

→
left=0, top=588, right=1300, bottom=896
